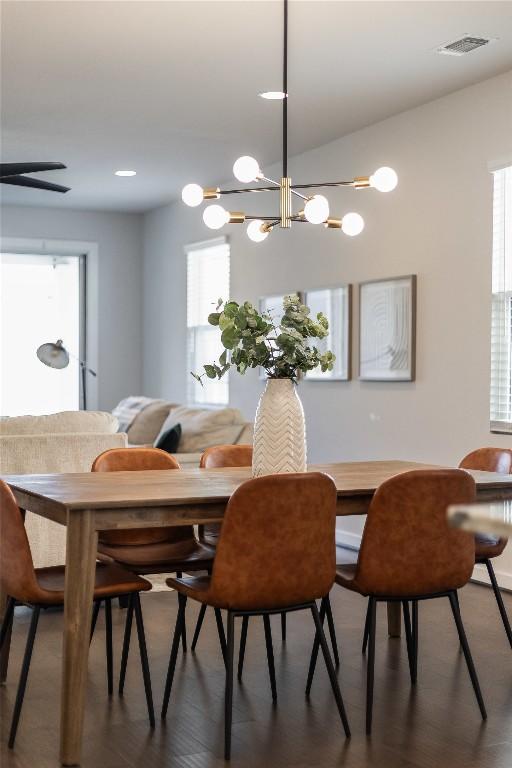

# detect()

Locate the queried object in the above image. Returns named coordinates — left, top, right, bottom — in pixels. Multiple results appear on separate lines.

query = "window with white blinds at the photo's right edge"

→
left=491, top=166, right=512, bottom=434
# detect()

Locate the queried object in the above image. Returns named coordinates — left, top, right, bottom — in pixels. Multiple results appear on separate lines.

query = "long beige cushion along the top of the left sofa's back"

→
left=0, top=411, right=118, bottom=435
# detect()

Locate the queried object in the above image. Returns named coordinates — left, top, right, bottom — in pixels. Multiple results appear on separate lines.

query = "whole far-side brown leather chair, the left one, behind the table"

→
left=92, top=448, right=217, bottom=680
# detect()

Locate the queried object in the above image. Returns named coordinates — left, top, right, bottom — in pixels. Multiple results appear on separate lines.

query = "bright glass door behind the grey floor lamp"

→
left=0, top=253, right=85, bottom=416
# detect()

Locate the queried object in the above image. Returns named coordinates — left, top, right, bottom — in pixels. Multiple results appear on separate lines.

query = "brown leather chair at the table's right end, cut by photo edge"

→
left=459, top=448, right=512, bottom=647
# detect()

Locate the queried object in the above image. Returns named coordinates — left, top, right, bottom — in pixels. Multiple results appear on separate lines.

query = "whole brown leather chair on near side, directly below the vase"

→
left=162, top=472, right=350, bottom=760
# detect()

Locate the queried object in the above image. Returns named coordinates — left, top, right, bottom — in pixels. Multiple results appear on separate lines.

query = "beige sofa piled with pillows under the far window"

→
left=122, top=400, right=253, bottom=468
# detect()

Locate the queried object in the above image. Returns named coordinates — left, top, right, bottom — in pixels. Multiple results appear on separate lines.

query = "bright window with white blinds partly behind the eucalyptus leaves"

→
left=185, top=238, right=229, bottom=405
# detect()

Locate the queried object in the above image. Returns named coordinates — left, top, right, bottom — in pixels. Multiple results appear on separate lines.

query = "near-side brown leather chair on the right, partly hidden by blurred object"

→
left=306, top=469, right=487, bottom=733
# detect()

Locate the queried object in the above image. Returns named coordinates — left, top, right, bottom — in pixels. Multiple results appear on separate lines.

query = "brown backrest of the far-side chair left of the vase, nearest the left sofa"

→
left=92, top=448, right=186, bottom=547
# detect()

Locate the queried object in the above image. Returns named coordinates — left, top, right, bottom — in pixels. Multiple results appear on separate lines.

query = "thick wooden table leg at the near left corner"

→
left=60, top=510, right=98, bottom=765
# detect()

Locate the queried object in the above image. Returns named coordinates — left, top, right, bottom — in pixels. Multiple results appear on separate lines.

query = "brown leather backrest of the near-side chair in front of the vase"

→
left=206, top=472, right=336, bottom=610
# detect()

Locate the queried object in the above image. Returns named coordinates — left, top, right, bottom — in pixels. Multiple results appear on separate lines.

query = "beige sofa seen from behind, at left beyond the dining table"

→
left=0, top=411, right=127, bottom=567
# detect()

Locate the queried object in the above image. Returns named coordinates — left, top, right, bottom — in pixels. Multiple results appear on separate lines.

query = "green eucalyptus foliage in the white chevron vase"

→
left=192, top=294, right=335, bottom=384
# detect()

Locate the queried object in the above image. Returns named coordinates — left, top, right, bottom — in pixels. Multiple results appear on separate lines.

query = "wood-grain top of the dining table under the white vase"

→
left=2, top=461, right=512, bottom=510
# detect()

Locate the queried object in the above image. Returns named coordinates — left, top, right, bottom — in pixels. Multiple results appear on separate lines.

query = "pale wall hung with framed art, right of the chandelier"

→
left=144, top=72, right=512, bottom=586
